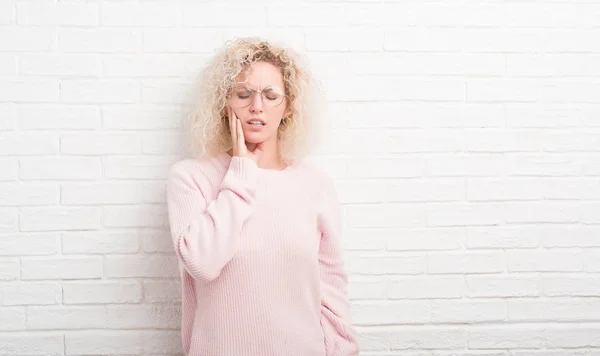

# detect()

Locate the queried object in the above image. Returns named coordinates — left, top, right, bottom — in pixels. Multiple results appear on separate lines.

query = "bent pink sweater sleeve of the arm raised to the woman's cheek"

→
left=167, top=157, right=258, bottom=281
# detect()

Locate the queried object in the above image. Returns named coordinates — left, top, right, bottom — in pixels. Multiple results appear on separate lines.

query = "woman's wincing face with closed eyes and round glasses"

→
left=228, top=62, right=287, bottom=143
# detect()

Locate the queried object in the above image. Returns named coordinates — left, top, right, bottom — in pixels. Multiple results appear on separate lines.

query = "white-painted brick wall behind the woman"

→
left=0, top=0, right=600, bottom=356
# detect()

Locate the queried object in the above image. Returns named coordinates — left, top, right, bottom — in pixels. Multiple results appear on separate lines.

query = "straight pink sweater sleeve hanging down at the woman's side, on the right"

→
left=319, top=178, right=359, bottom=356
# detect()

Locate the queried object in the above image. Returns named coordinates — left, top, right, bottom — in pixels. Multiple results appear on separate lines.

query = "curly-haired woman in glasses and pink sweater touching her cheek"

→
left=167, top=38, right=359, bottom=356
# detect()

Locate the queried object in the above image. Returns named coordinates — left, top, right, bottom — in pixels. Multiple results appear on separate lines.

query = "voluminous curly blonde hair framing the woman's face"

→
left=187, top=37, right=326, bottom=162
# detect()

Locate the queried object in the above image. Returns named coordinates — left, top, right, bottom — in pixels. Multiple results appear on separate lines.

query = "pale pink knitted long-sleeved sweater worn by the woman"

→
left=167, top=152, right=359, bottom=356
